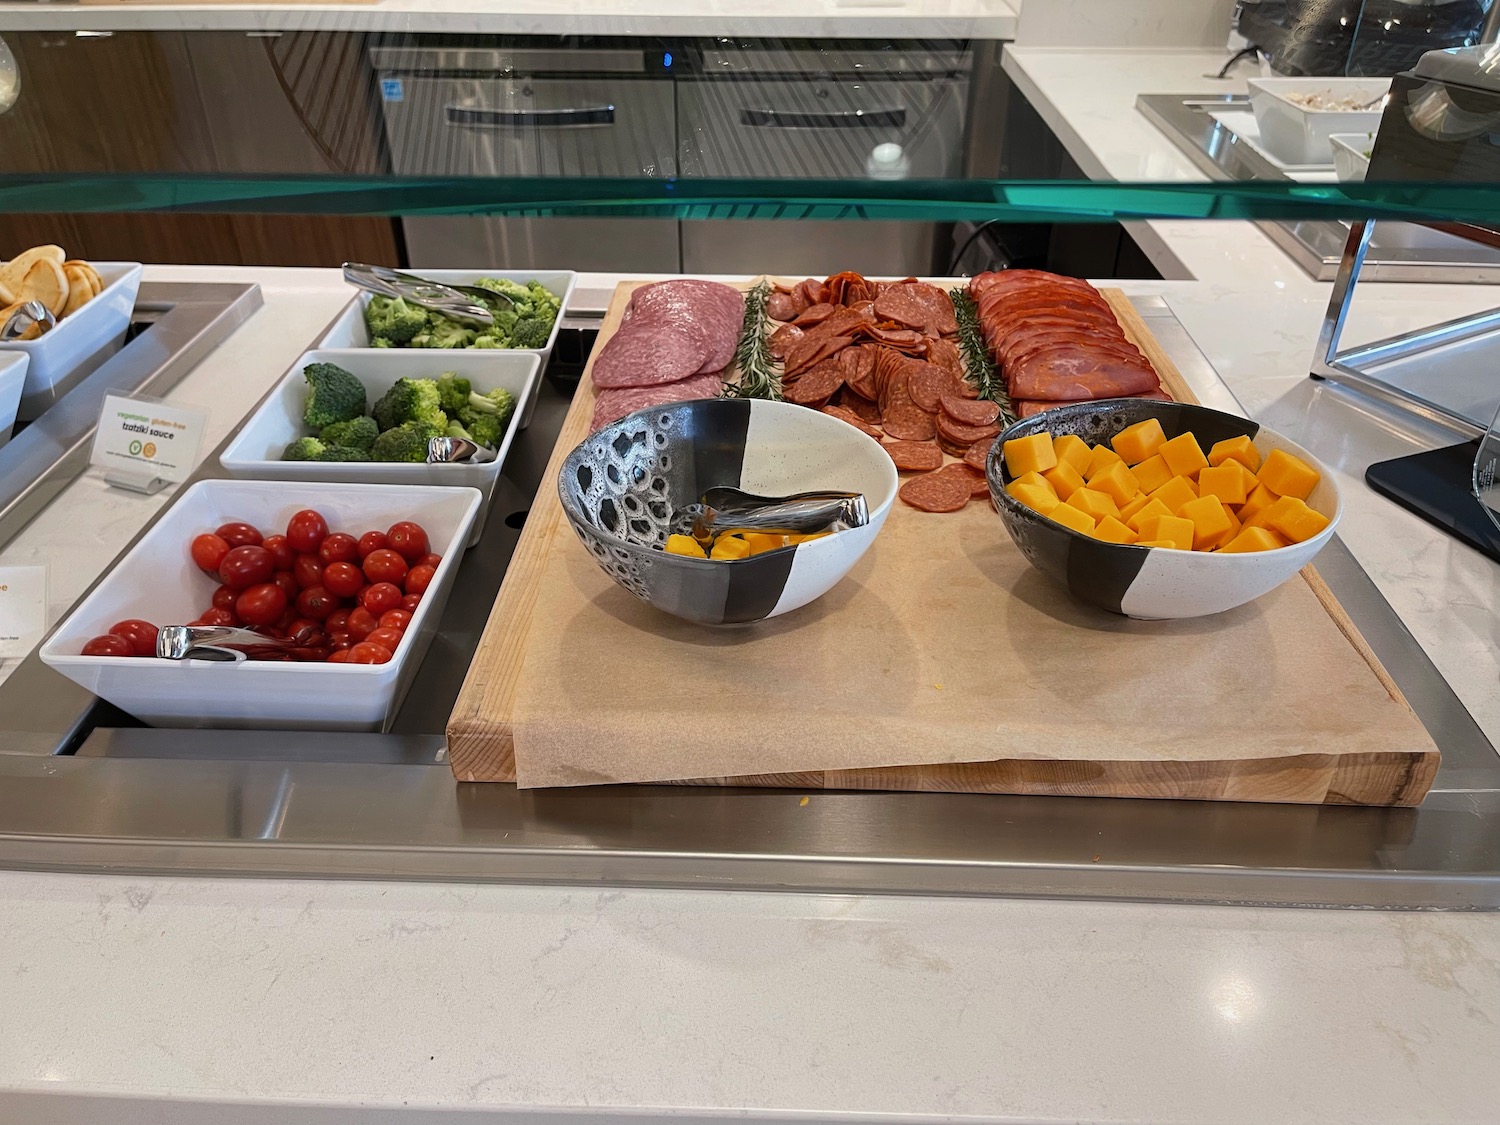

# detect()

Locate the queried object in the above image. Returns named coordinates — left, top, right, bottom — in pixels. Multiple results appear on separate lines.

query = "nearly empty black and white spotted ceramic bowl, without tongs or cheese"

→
left=558, top=399, right=897, bottom=626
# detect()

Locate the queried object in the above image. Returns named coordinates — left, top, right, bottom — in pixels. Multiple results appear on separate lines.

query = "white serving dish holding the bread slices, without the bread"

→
left=0, top=261, right=141, bottom=422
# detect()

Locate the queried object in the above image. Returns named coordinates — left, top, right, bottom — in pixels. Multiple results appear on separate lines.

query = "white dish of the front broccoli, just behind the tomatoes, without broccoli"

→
left=219, top=348, right=542, bottom=546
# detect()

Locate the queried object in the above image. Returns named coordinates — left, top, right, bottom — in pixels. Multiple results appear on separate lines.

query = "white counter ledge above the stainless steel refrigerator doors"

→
left=0, top=0, right=1016, bottom=39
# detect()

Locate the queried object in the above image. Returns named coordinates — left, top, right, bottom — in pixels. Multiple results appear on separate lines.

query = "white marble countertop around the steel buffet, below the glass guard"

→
left=0, top=262, right=1500, bottom=1125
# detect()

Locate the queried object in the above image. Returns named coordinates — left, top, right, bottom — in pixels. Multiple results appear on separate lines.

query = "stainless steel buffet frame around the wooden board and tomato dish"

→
left=0, top=299, right=1500, bottom=909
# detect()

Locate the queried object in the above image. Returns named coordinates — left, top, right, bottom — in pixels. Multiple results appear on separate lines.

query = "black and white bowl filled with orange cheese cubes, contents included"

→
left=987, top=399, right=1343, bottom=620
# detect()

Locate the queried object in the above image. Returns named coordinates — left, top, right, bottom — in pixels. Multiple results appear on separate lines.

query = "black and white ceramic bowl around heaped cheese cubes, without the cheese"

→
left=986, top=399, right=1343, bottom=620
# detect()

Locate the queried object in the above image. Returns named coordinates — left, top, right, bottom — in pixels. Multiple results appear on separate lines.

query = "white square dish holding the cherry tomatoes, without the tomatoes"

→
left=41, top=480, right=480, bottom=731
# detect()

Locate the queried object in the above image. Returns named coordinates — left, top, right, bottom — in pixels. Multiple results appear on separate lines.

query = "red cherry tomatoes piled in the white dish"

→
left=84, top=509, right=443, bottom=665
